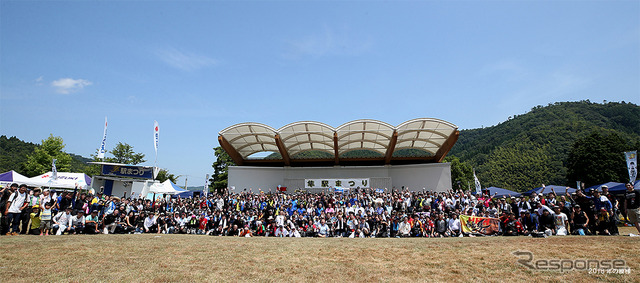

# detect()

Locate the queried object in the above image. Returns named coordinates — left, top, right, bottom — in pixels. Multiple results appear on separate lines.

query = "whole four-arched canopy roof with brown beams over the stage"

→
left=218, top=118, right=459, bottom=166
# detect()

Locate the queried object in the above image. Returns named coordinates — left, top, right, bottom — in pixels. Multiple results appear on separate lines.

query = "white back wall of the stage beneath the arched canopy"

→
left=229, top=163, right=451, bottom=193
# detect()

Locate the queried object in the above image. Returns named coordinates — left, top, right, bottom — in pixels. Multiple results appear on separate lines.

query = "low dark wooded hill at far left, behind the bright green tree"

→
left=0, top=135, right=91, bottom=177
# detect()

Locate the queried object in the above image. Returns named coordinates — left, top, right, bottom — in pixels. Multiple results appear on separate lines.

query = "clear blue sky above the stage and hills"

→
left=0, top=0, right=640, bottom=185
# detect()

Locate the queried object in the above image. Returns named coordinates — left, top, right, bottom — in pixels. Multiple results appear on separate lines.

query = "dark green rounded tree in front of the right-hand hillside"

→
left=567, top=132, right=638, bottom=186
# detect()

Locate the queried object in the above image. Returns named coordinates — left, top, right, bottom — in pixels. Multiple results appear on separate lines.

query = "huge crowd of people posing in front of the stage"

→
left=0, top=184, right=640, bottom=238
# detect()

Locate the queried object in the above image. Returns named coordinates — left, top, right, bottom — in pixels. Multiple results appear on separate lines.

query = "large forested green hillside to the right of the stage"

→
left=449, top=100, right=640, bottom=191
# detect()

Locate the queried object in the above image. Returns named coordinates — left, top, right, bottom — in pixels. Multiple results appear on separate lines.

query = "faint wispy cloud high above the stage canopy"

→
left=287, top=26, right=371, bottom=57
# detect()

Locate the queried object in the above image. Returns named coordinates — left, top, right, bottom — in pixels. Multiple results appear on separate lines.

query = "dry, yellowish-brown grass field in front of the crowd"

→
left=0, top=227, right=640, bottom=282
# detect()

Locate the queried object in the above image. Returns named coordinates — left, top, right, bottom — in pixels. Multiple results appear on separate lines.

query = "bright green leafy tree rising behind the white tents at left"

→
left=24, top=134, right=71, bottom=176
